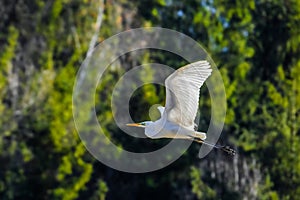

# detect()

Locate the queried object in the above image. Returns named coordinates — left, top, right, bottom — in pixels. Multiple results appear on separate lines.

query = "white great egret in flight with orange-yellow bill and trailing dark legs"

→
left=127, top=60, right=235, bottom=155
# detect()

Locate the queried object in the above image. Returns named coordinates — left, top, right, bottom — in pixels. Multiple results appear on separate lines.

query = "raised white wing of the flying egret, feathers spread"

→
left=165, top=61, right=212, bottom=129
